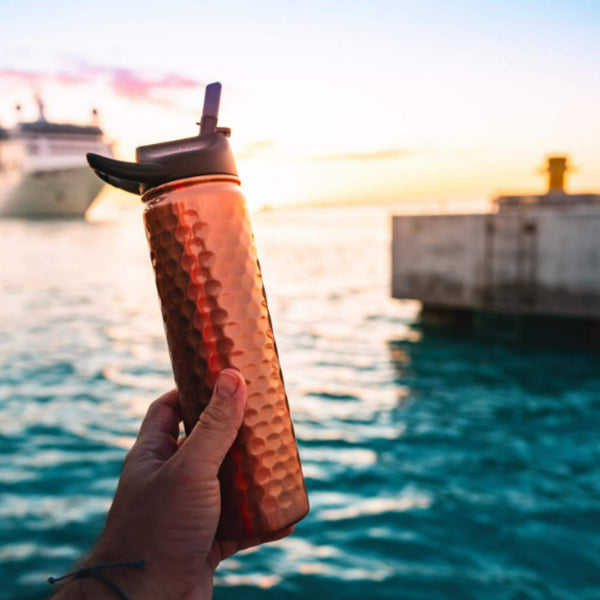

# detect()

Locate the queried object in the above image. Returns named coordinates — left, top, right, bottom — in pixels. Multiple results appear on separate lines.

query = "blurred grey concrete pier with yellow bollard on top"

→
left=392, top=159, right=600, bottom=320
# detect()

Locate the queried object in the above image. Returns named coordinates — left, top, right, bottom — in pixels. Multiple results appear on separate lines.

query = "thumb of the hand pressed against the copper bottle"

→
left=183, top=369, right=246, bottom=476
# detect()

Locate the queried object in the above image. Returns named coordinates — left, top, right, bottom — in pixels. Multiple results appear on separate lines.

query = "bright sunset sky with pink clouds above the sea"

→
left=0, top=0, right=600, bottom=208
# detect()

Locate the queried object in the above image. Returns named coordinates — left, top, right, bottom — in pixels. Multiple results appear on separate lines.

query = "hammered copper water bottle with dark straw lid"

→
left=88, top=83, right=308, bottom=540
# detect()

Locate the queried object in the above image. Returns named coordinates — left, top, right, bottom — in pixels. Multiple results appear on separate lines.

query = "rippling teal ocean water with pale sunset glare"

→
left=0, top=208, right=600, bottom=600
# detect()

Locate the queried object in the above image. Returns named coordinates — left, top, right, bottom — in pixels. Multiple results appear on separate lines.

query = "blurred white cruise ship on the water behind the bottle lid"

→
left=0, top=99, right=112, bottom=218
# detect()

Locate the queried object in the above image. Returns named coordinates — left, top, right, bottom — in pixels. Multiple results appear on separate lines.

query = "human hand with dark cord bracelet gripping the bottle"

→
left=57, top=369, right=293, bottom=600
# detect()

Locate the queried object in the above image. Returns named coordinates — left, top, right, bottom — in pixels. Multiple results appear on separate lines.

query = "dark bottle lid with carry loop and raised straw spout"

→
left=86, top=82, right=237, bottom=194
